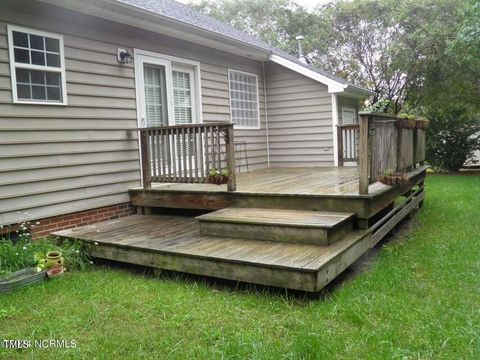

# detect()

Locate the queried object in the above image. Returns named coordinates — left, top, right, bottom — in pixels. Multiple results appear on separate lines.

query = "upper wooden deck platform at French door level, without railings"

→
left=130, top=166, right=427, bottom=229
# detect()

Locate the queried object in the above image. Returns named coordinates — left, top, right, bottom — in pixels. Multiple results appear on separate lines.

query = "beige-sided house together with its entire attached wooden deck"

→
left=0, top=0, right=426, bottom=291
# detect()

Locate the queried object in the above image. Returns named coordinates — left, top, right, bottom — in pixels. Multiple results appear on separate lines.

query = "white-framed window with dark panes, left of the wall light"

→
left=8, top=25, right=67, bottom=105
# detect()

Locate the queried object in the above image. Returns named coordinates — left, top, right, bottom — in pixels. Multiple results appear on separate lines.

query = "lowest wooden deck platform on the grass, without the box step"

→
left=53, top=215, right=372, bottom=291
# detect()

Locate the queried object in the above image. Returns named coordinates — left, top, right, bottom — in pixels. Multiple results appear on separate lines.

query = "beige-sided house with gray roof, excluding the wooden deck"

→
left=0, top=0, right=371, bottom=232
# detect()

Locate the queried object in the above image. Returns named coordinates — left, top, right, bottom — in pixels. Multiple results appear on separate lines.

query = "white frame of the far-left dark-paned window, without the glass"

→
left=7, top=24, right=68, bottom=106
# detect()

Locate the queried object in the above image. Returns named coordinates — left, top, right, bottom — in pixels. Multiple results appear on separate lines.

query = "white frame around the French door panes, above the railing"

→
left=133, top=49, right=203, bottom=127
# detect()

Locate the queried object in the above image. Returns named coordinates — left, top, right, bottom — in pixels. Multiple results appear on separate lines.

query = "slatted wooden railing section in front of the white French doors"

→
left=139, top=123, right=236, bottom=191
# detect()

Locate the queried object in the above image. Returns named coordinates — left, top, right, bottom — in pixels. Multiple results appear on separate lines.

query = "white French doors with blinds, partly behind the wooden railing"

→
left=135, top=51, right=197, bottom=177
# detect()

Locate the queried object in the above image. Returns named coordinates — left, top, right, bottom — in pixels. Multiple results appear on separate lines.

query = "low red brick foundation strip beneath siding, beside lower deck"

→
left=31, top=203, right=135, bottom=239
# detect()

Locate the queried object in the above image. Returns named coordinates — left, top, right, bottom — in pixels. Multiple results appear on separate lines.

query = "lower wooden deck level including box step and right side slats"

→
left=53, top=170, right=425, bottom=292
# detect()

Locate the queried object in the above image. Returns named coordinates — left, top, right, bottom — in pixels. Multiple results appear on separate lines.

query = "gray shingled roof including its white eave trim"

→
left=39, top=0, right=374, bottom=97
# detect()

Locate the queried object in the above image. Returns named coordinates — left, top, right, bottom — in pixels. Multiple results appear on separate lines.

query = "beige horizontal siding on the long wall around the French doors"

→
left=0, top=1, right=266, bottom=224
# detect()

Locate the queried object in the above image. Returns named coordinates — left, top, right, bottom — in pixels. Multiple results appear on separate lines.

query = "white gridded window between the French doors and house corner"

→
left=228, top=70, right=260, bottom=129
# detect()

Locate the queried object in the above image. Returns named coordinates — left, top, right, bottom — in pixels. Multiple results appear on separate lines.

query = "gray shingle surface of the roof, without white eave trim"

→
left=117, top=0, right=368, bottom=89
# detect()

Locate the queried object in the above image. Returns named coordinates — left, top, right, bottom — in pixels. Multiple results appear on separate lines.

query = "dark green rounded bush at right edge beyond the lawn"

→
left=426, top=109, right=480, bottom=171
